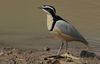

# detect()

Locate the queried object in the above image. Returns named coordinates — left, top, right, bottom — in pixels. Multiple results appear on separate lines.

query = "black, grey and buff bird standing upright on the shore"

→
left=39, top=5, right=88, bottom=55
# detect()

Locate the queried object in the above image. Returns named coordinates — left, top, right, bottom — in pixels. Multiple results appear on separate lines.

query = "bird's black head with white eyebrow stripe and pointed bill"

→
left=39, top=5, right=56, bottom=15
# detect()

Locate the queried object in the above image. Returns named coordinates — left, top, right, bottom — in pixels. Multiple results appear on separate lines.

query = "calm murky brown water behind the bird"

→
left=0, top=0, right=100, bottom=51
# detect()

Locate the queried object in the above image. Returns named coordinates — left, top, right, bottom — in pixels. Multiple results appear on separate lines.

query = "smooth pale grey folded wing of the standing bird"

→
left=55, top=20, right=88, bottom=45
